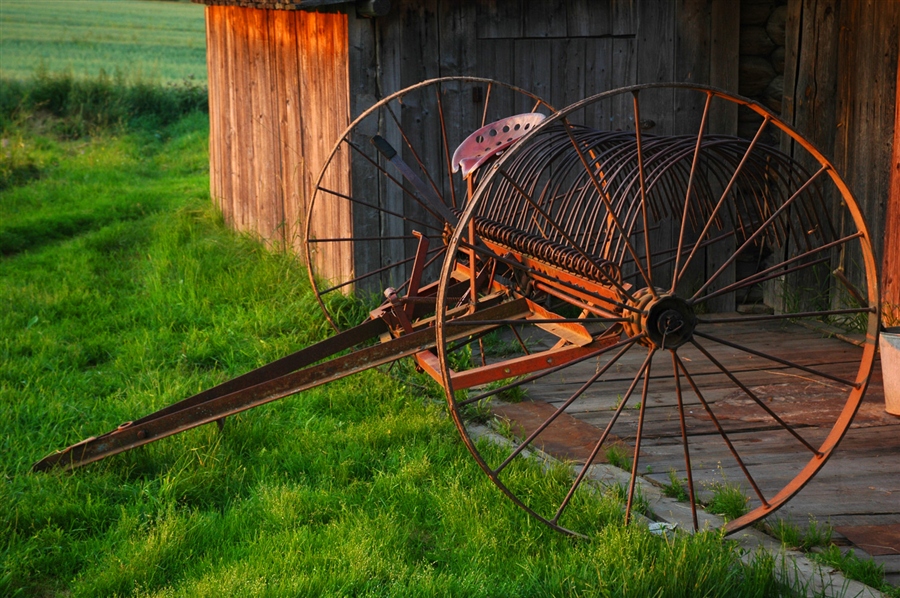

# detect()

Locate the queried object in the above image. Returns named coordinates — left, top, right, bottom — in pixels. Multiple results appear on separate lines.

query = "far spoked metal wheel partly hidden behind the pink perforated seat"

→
left=305, top=77, right=552, bottom=329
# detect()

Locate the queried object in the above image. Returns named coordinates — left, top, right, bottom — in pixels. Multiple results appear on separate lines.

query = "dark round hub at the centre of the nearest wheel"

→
left=625, top=289, right=697, bottom=349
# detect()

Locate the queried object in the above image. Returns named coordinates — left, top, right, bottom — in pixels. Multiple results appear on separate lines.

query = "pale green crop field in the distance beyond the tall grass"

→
left=0, top=0, right=206, bottom=83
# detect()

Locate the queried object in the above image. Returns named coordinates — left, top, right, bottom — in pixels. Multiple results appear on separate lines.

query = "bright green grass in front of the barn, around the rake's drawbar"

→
left=0, top=98, right=800, bottom=596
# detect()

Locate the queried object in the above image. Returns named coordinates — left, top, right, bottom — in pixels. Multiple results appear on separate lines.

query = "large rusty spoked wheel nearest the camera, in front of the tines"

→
left=436, top=84, right=878, bottom=533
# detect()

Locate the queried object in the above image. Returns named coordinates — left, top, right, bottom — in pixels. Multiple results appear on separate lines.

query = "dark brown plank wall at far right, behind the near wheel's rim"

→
left=782, top=0, right=900, bottom=316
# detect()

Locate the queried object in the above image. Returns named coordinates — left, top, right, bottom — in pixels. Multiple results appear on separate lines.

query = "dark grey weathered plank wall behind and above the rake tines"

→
left=349, top=0, right=740, bottom=310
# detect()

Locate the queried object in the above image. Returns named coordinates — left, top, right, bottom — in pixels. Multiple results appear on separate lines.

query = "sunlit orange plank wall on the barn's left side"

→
left=206, top=5, right=350, bottom=249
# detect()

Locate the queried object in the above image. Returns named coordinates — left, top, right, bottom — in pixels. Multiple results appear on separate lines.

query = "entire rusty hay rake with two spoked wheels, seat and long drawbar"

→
left=35, top=77, right=878, bottom=532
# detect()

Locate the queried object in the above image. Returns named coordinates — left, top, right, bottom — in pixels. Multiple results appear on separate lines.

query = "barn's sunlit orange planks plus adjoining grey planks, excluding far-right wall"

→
left=200, top=0, right=739, bottom=268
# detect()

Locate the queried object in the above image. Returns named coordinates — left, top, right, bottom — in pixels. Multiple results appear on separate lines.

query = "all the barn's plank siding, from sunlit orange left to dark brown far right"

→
left=200, top=0, right=900, bottom=310
